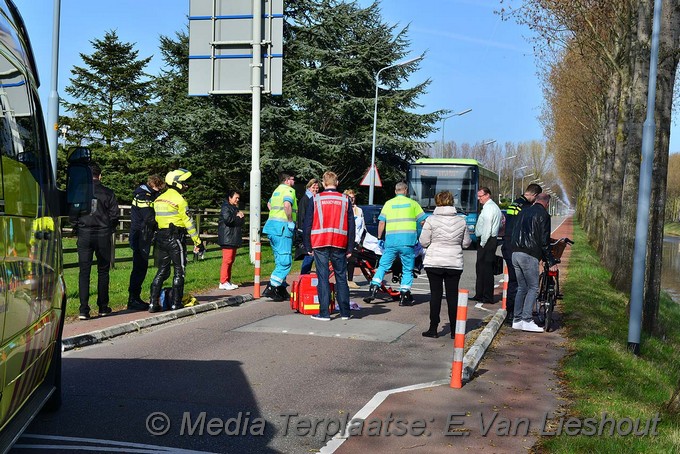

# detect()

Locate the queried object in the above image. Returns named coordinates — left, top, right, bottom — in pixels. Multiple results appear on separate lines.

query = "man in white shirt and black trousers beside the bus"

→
left=470, top=187, right=503, bottom=304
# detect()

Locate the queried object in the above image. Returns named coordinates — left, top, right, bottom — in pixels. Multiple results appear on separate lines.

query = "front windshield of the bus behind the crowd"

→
left=408, top=164, right=478, bottom=214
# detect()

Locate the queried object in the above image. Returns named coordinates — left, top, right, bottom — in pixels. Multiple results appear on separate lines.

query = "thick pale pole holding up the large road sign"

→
left=249, top=0, right=262, bottom=263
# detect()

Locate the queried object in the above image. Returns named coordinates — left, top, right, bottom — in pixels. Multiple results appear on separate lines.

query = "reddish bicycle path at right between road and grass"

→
left=330, top=217, right=573, bottom=454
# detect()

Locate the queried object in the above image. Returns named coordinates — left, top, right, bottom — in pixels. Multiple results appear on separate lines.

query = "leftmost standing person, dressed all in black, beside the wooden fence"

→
left=74, top=162, right=118, bottom=320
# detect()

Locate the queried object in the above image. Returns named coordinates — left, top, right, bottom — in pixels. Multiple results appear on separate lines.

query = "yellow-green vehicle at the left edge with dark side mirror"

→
left=0, top=0, right=81, bottom=452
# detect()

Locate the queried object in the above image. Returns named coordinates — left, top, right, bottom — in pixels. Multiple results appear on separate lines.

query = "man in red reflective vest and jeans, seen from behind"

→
left=303, top=171, right=354, bottom=321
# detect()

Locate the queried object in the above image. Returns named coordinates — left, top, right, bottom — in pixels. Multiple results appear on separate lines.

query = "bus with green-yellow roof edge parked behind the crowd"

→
left=406, top=158, right=498, bottom=244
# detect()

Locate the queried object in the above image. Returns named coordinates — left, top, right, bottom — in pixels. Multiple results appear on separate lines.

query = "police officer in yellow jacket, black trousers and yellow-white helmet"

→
left=149, top=169, right=204, bottom=312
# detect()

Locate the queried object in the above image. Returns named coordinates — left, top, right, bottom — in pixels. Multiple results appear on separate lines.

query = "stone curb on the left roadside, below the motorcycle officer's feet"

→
left=61, top=294, right=253, bottom=352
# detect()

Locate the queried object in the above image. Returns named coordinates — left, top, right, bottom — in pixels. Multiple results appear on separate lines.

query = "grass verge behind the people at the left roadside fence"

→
left=63, top=238, right=286, bottom=319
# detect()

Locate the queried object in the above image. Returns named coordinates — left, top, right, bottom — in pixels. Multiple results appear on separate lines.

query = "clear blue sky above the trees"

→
left=15, top=0, right=680, bottom=151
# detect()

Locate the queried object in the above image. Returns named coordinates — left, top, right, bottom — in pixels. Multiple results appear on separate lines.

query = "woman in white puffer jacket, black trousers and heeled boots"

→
left=420, top=191, right=471, bottom=338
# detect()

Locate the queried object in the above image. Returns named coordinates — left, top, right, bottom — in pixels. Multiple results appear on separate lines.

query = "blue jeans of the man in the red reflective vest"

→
left=314, top=247, right=350, bottom=317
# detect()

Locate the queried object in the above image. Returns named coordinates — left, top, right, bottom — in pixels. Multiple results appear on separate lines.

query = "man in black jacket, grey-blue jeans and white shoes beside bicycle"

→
left=512, top=193, right=558, bottom=333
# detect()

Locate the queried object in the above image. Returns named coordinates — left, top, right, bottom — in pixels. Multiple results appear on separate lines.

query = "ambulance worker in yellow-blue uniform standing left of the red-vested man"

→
left=262, top=173, right=297, bottom=301
